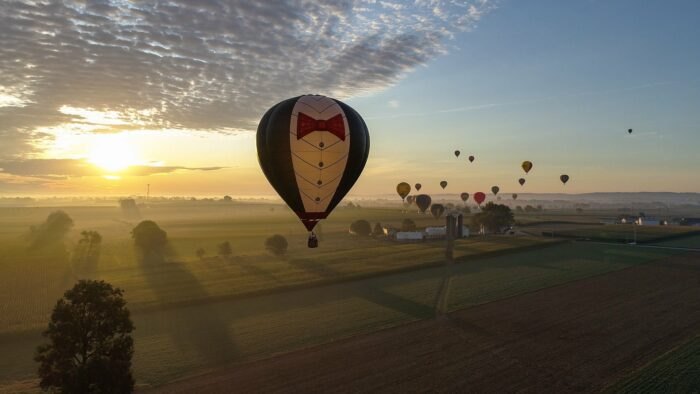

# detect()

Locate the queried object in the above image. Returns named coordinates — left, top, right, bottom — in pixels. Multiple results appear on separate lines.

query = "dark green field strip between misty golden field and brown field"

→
left=0, top=239, right=673, bottom=391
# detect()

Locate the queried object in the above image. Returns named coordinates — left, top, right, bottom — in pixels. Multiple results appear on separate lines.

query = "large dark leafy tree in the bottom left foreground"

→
left=34, top=280, right=134, bottom=393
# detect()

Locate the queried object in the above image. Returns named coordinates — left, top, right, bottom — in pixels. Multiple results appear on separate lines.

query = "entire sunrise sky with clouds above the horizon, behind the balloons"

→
left=0, top=0, right=700, bottom=197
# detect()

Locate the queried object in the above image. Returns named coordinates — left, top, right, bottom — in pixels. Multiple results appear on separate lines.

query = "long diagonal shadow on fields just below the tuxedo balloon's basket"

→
left=289, top=259, right=435, bottom=319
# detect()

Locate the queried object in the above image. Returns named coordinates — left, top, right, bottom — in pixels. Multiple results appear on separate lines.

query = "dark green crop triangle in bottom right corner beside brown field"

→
left=608, top=337, right=700, bottom=393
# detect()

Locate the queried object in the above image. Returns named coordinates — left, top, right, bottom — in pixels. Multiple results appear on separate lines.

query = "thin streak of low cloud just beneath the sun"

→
left=0, top=159, right=224, bottom=180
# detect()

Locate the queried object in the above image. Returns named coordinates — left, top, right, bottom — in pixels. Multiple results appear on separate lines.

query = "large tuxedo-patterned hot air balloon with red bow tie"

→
left=257, top=95, right=369, bottom=247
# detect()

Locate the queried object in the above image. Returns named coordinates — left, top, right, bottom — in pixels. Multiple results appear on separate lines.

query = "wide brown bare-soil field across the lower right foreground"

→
left=150, top=254, right=700, bottom=393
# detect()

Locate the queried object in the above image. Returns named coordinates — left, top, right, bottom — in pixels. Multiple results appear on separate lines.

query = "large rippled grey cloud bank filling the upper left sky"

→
left=0, top=0, right=494, bottom=159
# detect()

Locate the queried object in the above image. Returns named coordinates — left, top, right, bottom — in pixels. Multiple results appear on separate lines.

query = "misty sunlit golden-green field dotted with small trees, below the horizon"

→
left=0, top=205, right=551, bottom=334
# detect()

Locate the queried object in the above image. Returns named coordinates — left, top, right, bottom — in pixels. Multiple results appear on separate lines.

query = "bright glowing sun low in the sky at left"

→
left=88, top=134, right=138, bottom=173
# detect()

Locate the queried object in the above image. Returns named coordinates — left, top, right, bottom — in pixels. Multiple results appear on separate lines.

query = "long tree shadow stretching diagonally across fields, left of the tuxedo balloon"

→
left=137, top=251, right=238, bottom=363
